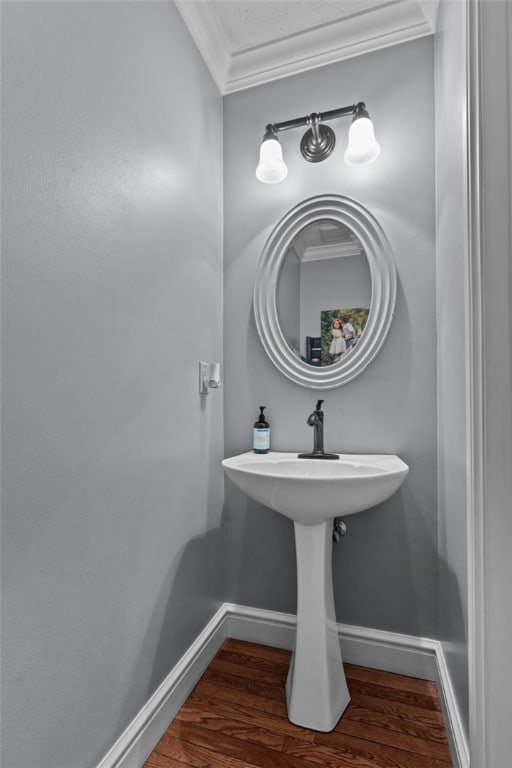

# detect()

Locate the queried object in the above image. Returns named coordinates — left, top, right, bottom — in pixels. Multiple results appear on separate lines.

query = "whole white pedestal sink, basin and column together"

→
left=222, top=452, right=409, bottom=731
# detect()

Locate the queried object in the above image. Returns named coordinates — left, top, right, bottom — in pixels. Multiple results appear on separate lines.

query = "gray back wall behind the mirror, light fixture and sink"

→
left=224, top=38, right=438, bottom=637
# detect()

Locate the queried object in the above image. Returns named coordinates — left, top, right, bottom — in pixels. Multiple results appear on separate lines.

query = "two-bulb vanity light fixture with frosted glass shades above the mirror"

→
left=256, top=101, right=380, bottom=184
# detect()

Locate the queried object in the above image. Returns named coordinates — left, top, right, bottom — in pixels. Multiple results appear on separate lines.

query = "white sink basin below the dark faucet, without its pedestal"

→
left=222, top=452, right=409, bottom=525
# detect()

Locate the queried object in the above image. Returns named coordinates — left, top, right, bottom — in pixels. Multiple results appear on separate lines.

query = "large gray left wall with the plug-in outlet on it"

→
left=2, top=2, right=223, bottom=768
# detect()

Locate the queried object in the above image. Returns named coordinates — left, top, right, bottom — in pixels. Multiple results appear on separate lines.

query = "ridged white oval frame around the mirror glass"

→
left=254, top=195, right=397, bottom=389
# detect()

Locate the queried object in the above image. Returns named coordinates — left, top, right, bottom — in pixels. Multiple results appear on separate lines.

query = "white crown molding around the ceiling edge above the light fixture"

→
left=175, top=0, right=438, bottom=94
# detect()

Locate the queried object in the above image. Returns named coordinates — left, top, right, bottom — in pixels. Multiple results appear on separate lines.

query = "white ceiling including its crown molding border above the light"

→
left=176, top=0, right=439, bottom=93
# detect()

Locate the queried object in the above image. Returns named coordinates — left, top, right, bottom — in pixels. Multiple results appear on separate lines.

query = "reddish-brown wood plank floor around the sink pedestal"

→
left=144, top=640, right=452, bottom=768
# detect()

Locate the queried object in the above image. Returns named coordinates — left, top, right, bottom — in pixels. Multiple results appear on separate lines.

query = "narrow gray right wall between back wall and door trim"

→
left=435, top=2, right=468, bottom=729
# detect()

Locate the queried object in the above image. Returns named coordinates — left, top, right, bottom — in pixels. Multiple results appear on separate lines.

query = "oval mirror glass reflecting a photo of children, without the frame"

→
left=276, top=219, right=372, bottom=367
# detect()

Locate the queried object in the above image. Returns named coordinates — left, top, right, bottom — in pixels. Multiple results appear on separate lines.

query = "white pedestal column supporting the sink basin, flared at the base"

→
left=286, top=520, right=350, bottom=731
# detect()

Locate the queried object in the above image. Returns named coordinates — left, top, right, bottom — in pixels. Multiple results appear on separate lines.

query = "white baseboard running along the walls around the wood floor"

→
left=97, top=603, right=469, bottom=768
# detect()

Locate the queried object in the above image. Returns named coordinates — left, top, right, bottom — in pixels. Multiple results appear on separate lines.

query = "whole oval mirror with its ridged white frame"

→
left=254, top=195, right=396, bottom=389
